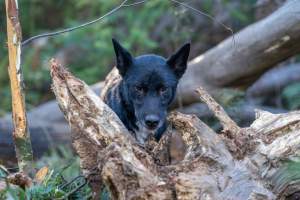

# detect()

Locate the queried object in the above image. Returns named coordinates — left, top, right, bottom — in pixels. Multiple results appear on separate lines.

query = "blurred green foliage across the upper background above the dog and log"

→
left=0, top=0, right=256, bottom=115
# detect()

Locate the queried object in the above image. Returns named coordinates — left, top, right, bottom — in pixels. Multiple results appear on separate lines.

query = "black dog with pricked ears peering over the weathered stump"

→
left=105, top=39, right=190, bottom=143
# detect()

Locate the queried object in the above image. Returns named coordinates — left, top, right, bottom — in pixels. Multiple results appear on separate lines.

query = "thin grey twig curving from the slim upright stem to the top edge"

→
left=22, top=0, right=133, bottom=46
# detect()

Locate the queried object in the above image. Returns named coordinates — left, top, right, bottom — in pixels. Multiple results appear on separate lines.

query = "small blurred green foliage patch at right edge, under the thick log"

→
left=281, top=83, right=300, bottom=110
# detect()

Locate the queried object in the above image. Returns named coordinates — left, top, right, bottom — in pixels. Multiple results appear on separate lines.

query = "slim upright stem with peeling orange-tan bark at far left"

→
left=5, top=0, right=32, bottom=173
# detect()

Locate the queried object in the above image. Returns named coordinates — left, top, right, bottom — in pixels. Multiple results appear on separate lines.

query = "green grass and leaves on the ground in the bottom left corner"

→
left=0, top=147, right=91, bottom=200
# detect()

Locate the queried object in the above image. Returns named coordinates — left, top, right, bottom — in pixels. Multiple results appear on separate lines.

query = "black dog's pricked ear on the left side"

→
left=112, top=39, right=133, bottom=76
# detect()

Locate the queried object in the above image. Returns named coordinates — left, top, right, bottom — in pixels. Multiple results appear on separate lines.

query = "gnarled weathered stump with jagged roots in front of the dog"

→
left=51, top=61, right=300, bottom=200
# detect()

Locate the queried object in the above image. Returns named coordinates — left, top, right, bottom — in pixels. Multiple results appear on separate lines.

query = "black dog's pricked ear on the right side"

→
left=167, top=43, right=191, bottom=79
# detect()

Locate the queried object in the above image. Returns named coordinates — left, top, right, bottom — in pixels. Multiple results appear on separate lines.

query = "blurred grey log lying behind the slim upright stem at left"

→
left=0, top=84, right=103, bottom=167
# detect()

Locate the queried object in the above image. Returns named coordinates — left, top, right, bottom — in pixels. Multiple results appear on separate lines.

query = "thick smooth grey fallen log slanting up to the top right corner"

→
left=178, top=0, right=300, bottom=105
